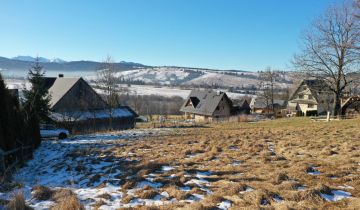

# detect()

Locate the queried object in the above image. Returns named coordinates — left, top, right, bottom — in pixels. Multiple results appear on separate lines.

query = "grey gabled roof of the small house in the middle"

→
left=180, top=90, right=231, bottom=116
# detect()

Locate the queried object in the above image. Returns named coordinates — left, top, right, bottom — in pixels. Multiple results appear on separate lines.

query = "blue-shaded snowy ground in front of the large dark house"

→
left=0, top=129, right=175, bottom=209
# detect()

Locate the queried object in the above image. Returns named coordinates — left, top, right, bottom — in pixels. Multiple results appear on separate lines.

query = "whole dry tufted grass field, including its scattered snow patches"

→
left=2, top=118, right=360, bottom=210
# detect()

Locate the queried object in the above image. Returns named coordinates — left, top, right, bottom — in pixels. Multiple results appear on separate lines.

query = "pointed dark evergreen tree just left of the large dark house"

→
left=23, top=58, right=50, bottom=147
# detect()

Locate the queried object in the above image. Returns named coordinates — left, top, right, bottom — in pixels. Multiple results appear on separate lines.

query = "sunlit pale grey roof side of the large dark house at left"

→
left=49, top=77, right=81, bottom=108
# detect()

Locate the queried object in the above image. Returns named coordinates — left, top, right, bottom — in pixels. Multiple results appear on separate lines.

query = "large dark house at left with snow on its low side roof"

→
left=45, top=75, right=138, bottom=133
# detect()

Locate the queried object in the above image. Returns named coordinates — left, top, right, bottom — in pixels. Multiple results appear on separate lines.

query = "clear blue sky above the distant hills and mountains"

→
left=0, top=0, right=340, bottom=71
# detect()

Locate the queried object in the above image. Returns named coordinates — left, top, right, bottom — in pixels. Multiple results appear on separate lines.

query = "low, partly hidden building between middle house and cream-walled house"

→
left=250, top=97, right=287, bottom=117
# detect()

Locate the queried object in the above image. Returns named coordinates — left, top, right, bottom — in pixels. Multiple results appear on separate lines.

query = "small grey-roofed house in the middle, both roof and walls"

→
left=180, top=90, right=232, bottom=122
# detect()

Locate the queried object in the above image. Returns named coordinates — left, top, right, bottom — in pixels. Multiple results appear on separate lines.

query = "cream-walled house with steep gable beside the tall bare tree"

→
left=288, top=79, right=334, bottom=116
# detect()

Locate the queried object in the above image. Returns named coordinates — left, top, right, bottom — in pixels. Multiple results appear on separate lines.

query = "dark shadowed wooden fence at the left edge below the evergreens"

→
left=0, top=144, right=33, bottom=175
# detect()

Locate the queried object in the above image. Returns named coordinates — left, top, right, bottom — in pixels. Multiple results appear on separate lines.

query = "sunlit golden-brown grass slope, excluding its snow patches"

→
left=115, top=118, right=360, bottom=209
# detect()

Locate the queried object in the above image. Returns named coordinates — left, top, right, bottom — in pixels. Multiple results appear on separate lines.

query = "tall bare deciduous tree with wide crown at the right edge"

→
left=293, top=3, right=360, bottom=115
